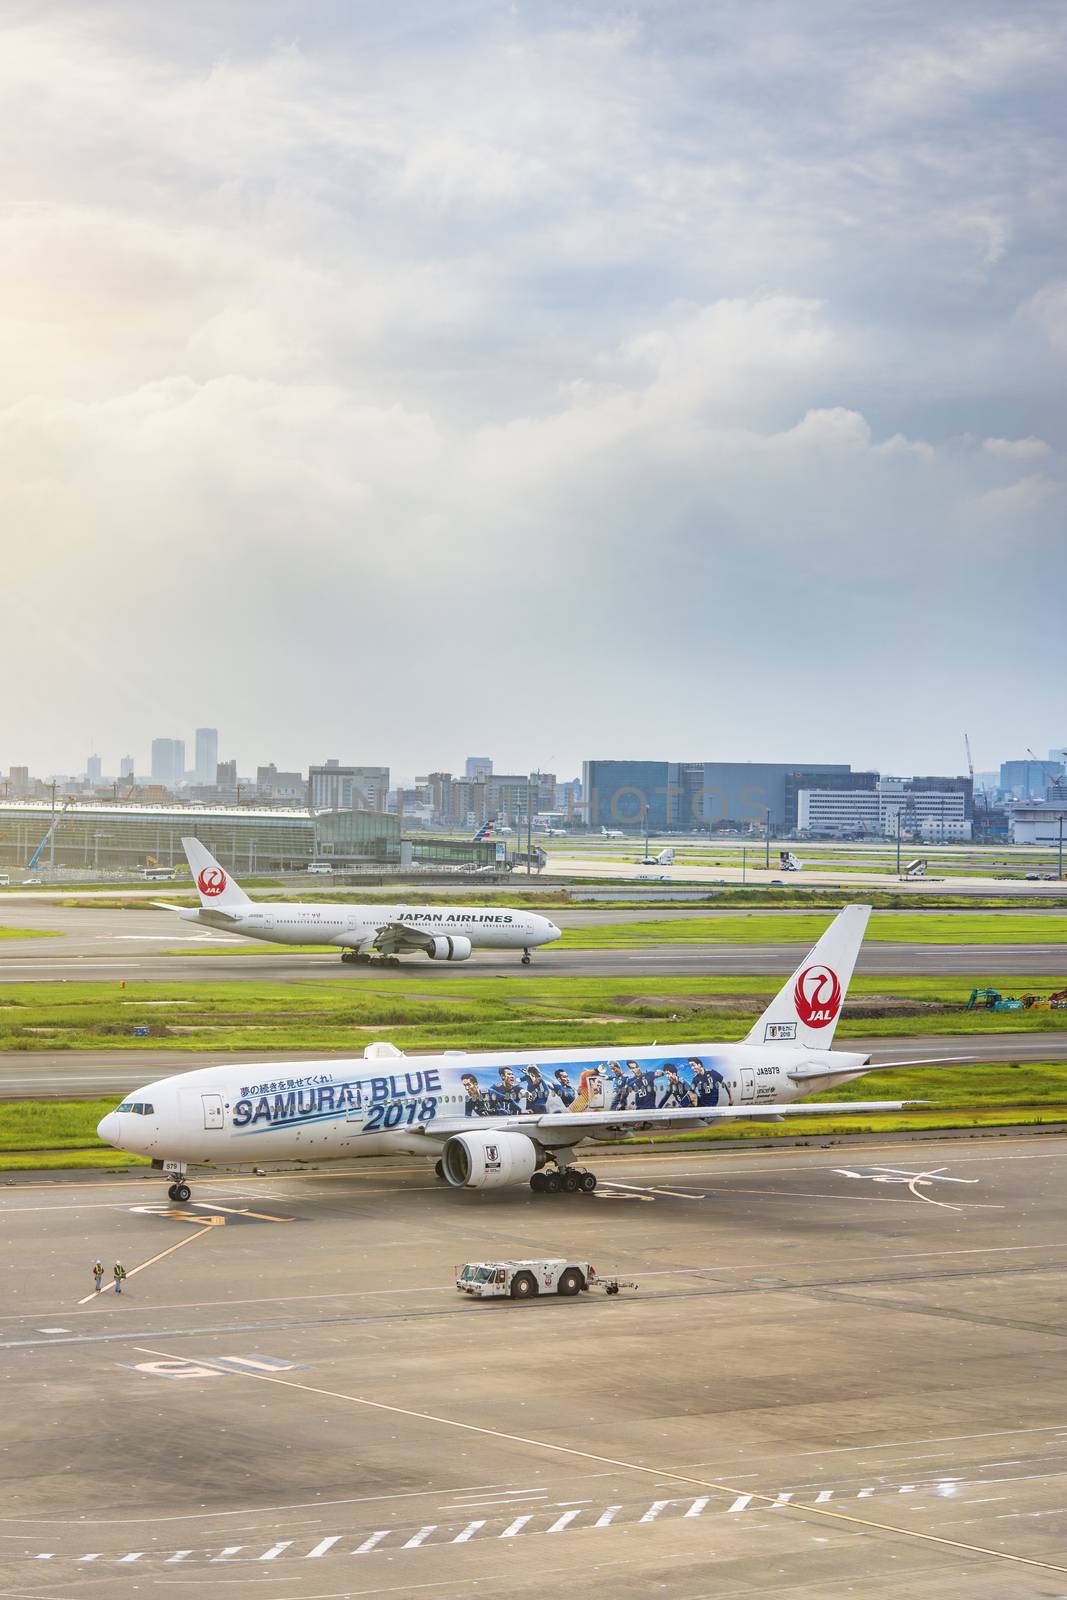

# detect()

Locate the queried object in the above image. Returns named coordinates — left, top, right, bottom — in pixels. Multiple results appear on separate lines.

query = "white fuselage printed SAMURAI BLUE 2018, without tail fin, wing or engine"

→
left=99, top=1043, right=869, bottom=1166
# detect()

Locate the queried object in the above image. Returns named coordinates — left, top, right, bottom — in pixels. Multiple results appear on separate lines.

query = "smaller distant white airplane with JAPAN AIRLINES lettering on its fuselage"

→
left=163, top=838, right=560, bottom=966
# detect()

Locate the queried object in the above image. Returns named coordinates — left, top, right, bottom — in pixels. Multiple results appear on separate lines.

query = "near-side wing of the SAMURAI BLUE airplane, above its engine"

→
left=422, top=1101, right=926, bottom=1144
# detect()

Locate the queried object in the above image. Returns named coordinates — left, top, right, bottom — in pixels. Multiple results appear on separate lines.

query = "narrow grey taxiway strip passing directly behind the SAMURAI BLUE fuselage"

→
left=0, top=1022, right=1067, bottom=1101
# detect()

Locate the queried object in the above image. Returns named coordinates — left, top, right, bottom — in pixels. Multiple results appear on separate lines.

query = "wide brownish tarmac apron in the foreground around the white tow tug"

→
left=0, top=1136, right=1067, bottom=1600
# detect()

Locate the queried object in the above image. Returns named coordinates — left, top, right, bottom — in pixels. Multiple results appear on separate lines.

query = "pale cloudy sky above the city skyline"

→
left=0, top=0, right=1067, bottom=776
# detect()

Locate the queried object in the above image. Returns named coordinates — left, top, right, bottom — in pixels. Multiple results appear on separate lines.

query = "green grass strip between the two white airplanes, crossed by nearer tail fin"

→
left=0, top=968, right=1067, bottom=1053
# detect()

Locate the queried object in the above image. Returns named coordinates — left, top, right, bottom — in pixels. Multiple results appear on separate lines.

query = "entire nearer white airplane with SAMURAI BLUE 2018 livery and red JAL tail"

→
left=98, top=906, right=968, bottom=1202
